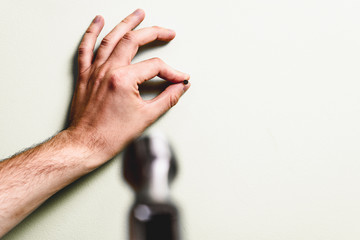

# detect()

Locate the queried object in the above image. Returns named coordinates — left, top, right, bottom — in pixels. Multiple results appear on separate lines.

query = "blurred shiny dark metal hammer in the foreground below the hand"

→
left=123, top=134, right=180, bottom=240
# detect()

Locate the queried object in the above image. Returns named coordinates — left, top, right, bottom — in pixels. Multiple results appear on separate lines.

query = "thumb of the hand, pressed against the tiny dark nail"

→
left=148, top=81, right=191, bottom=119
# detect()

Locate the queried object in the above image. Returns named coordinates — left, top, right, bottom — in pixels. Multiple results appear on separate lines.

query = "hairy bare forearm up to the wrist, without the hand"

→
left=0, top=131, right=96, bottom=238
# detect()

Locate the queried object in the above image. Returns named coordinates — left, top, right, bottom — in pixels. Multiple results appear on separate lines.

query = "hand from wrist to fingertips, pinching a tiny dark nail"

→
left=69, top=9, right=190, bottom=167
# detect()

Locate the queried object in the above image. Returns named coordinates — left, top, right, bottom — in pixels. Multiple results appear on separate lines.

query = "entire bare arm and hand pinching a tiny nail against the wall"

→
left=0, top=9, right=190, bottom=238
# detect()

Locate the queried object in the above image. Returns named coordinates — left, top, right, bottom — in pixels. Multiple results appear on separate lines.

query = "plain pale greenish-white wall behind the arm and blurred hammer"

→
left=0, top=0, right=360, bottom=240
